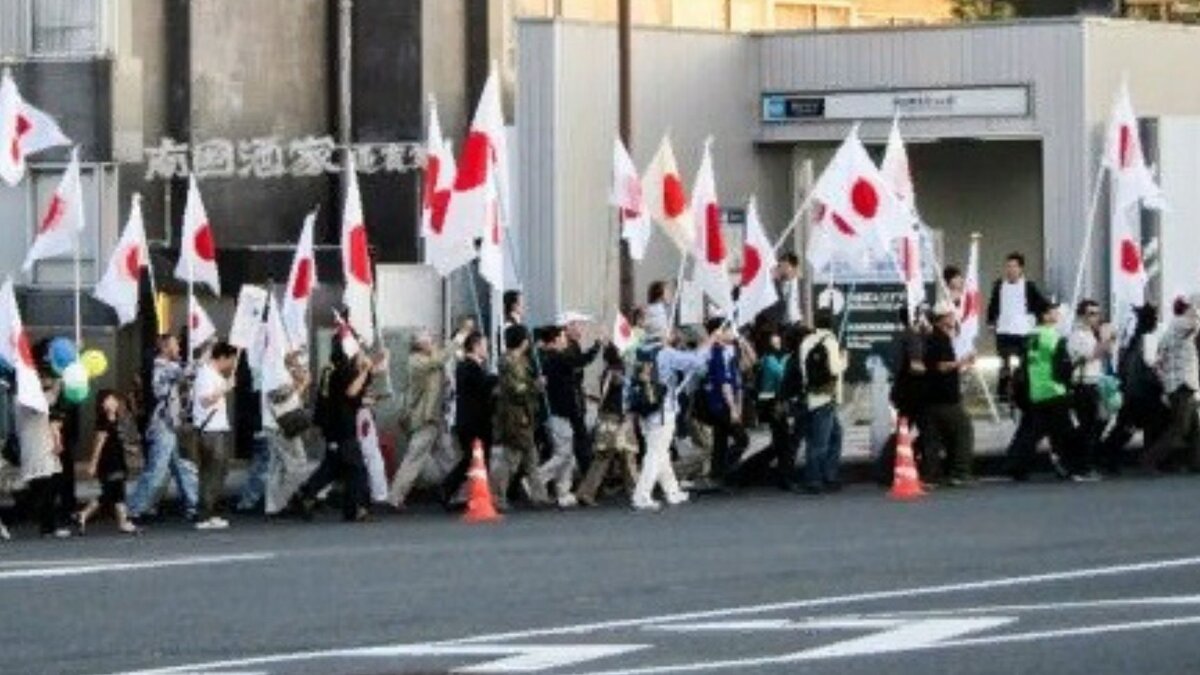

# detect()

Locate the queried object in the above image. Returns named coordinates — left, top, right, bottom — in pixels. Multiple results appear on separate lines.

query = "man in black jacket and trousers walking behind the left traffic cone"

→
left=442, top=331, right=499, bottom=504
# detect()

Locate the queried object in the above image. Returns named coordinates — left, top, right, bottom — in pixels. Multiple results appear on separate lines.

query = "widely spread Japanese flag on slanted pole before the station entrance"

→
left=812, top=127, right=914, bottom=255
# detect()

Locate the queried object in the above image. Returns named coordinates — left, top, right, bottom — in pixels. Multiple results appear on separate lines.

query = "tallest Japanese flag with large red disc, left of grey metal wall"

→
left=446, top=68, right=509, bottom=288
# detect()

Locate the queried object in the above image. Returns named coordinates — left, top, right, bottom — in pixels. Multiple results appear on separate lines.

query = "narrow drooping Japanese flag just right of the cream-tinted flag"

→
left=691, top=139, right=733, bottom=315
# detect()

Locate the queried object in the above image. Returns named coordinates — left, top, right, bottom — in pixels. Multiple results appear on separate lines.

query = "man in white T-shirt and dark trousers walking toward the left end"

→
left=192, top=342, right=239, bottom=530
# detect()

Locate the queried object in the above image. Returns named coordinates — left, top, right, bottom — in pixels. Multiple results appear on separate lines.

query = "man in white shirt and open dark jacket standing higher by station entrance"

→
left=988, top=252, right=1048, bottom=398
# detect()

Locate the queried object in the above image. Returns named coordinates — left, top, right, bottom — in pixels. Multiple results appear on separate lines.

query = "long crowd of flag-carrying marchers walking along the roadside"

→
left=0, top=253, right=1200, bottom=538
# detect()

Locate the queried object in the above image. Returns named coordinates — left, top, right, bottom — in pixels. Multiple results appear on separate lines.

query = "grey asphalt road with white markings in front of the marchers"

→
left=0, top=478, right=1200, bottom=675
